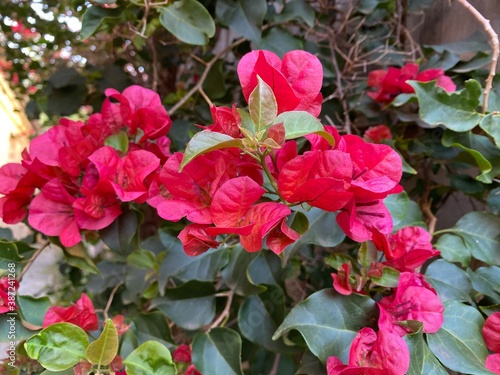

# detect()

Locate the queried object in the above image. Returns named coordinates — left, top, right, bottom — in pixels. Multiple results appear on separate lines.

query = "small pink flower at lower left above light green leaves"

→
left=42, top=293, right=99, bottom=331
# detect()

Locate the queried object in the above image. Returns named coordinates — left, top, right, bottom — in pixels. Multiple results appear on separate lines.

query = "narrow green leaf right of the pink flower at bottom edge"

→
left=404, top=321, right=448, bottom=375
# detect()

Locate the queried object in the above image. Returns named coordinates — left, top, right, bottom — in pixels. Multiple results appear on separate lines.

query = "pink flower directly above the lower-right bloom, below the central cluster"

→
left=372, top=226, right=440, bottom=272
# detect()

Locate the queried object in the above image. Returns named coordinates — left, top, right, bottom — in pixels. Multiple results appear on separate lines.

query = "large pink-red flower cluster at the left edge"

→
left=0, top=86, right=171, bottom=246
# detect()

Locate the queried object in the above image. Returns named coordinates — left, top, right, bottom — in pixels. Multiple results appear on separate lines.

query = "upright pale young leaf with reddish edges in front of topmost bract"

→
left=248, top=76, right=278, bottom=131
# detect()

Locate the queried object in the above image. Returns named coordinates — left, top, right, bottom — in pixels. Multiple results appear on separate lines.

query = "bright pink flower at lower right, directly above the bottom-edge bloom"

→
left=378, top=272, right=444, bottom=336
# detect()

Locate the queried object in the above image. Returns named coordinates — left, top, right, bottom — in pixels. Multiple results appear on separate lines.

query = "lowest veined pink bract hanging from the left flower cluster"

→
left=28, top=178, right=82, bottom=247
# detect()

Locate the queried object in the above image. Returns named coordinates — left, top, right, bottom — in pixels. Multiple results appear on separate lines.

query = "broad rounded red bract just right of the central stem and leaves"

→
left=278, top=150, right=353, bottom=212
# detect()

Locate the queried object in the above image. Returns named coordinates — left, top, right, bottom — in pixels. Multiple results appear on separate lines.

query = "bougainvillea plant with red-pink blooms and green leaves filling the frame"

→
left=0, top=0, right=500, bottom=375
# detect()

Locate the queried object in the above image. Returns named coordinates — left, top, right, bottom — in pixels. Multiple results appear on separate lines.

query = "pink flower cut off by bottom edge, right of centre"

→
left=327, top=327, right=410, bottom=375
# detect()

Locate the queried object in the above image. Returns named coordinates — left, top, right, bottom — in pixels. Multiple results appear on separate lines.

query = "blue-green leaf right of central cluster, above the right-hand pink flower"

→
left=384, top=191, right=426, bottom=231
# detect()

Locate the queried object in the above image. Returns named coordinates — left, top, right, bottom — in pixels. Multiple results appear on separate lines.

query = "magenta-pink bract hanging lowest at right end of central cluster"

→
left=336, top=199, right=392, bottom=242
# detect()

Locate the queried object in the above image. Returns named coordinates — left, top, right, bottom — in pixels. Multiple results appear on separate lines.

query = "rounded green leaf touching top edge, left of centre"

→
left=160, top=0, right=215, bottom=46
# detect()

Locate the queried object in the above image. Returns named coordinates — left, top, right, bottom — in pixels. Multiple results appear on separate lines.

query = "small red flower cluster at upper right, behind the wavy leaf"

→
left=367, top=63, right=457, bottom=104
